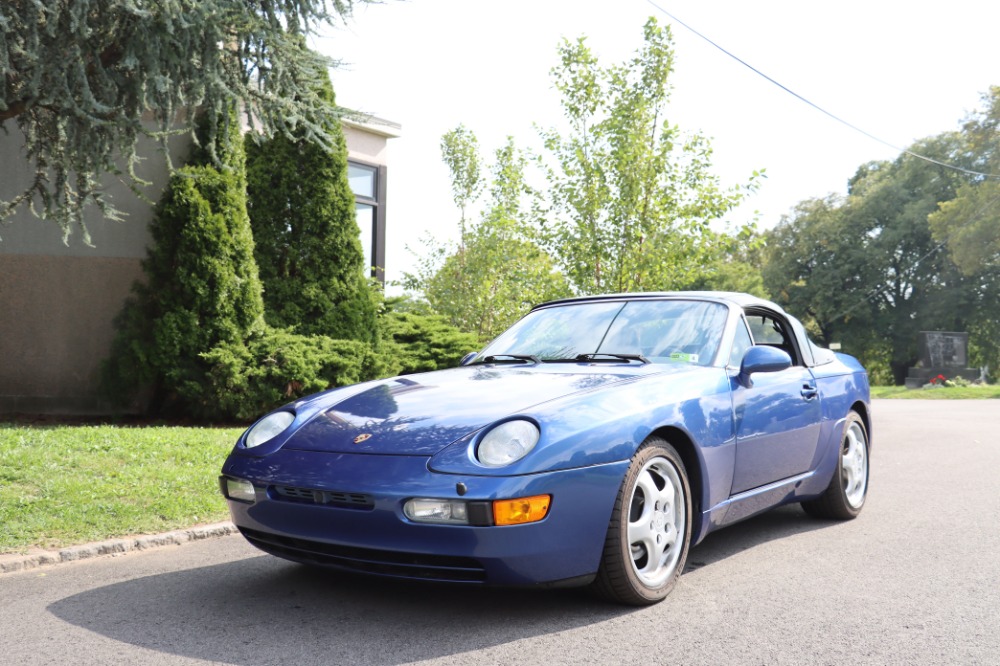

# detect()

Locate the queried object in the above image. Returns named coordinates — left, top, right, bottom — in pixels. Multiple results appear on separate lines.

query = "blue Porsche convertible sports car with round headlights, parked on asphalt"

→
left=220, top=292, right=871, bottom=605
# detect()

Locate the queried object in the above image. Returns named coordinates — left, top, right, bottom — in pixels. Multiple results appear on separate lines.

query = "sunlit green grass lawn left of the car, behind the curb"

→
left=0, top=423, right=241, bottom=553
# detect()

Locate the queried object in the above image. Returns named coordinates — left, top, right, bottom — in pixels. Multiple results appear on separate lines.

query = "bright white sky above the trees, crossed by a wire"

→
left=314, top=0, right=1000, bottom=280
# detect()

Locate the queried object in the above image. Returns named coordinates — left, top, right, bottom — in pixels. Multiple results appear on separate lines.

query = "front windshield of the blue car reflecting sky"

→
left=475, top=299, right=728, bottom=365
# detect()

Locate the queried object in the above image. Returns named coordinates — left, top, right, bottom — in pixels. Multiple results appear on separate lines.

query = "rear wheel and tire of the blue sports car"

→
left=802, top=411, right=871, bottom=520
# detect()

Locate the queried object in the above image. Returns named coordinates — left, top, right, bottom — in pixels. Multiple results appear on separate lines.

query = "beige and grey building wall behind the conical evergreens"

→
left=0, top=116, right=398, bottom=415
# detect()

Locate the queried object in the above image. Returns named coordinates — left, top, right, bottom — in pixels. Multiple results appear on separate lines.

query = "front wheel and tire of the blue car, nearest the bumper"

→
left=591, top=437, right=691, bottom=606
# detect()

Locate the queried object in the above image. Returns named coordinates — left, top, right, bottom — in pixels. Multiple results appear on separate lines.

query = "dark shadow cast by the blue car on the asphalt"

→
left=48, top=507, right=831, bottom=666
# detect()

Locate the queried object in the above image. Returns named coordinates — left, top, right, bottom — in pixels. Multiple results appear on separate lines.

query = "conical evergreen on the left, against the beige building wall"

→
left=104, top=114, right=264, bottom=416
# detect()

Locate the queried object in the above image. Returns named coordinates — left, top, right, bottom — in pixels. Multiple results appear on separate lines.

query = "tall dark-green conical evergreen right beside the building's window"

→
left=246, top=70, right=377, bottom=342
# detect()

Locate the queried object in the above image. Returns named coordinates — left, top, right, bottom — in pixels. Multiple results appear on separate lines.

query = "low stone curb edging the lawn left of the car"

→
left=0, top=523, right=239, bottom=575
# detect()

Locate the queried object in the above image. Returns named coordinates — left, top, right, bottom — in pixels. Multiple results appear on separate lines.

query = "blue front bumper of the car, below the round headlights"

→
left=222, top=450, right=628, bottom=585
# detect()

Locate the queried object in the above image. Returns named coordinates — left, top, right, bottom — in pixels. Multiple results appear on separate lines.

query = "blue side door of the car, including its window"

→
left=730, top=309, right=820, bottom=495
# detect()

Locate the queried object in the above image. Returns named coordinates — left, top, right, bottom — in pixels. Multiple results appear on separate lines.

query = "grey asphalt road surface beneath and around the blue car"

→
left=0, top=400, right=1000, bottom=666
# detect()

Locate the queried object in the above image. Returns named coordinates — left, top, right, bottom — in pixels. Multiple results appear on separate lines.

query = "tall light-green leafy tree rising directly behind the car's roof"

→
left=543, top=18, right=761, bottom=293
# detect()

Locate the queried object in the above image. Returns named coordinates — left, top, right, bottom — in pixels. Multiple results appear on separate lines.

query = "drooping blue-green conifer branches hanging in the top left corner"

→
left=0, top=0, right=355, bottom=239
